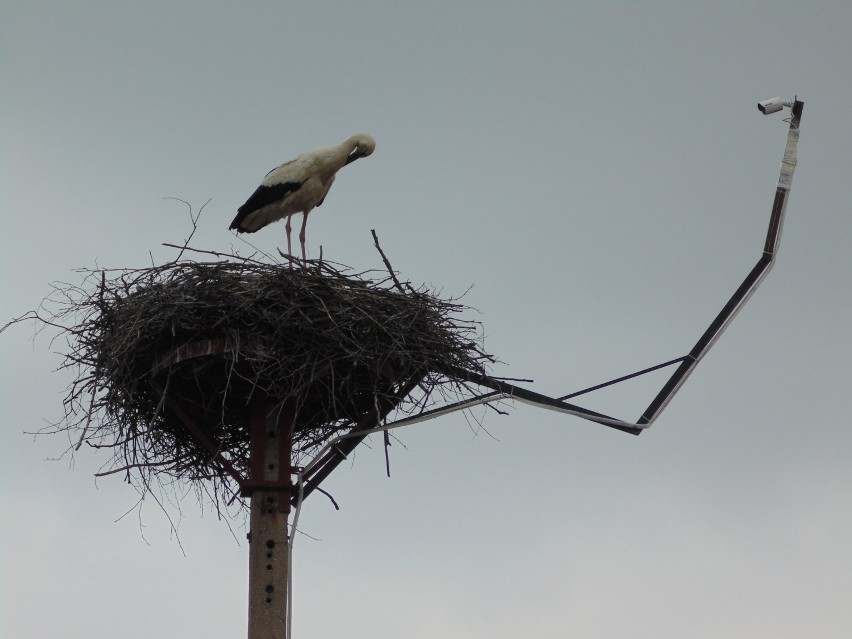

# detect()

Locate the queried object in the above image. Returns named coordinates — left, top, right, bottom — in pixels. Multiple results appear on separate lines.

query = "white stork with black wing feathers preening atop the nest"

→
left=229, top=133, right=376, bottom=260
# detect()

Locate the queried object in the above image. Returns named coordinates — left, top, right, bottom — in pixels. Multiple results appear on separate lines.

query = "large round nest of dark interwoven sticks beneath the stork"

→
left=15, top=245, right=493, bottom=504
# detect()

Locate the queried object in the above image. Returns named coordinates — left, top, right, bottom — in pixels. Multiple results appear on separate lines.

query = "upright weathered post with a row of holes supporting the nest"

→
left=243, top=399, right=295, bottom=639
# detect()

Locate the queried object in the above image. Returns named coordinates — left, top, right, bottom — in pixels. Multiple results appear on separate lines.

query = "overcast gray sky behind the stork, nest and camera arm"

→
left=0, top=0, right=852, bottom=639
